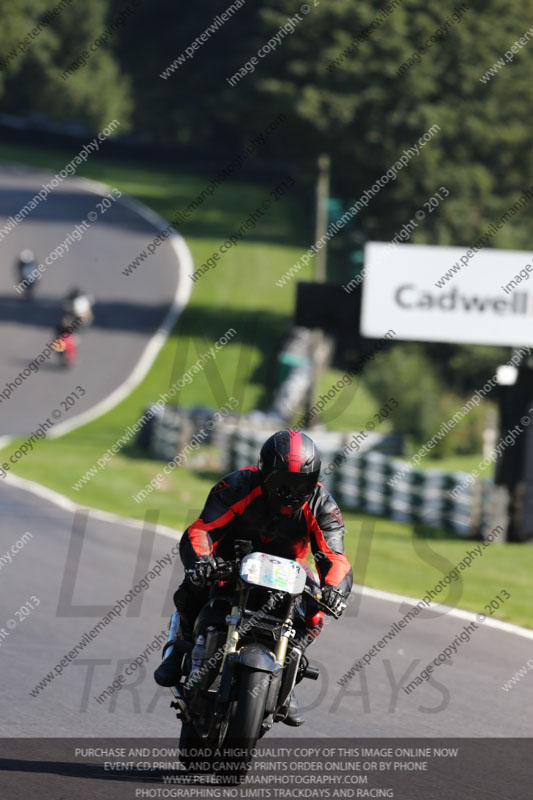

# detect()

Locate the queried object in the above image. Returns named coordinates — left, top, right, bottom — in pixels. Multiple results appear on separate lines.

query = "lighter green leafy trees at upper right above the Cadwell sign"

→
left=242, top=0, right=533, bottom=248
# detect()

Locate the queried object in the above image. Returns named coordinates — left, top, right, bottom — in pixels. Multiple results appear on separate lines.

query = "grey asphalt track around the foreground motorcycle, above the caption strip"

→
left=0, top=478, right=533, bottom=737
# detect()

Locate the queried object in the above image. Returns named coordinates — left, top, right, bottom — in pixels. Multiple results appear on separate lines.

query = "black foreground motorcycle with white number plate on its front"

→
left=163, top=540, right=338, bottom=779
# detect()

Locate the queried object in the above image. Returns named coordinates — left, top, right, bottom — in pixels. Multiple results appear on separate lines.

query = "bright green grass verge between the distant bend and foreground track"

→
left=0, top=145, right=533, bottom=627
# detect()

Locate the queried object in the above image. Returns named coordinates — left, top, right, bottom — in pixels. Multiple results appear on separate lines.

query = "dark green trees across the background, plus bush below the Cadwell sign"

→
left=0, top=0, right=533, bottom=452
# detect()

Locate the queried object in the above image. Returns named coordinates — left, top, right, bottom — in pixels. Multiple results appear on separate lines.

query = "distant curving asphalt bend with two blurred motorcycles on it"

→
left=0, top=167, right=184, bottom=436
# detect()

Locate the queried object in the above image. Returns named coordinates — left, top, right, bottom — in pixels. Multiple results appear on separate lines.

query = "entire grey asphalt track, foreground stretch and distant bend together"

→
left=0, top=166, right=533, bottom=800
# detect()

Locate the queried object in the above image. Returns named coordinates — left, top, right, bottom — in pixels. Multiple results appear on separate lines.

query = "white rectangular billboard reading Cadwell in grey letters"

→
left=361, top=242, right=533, bottom=346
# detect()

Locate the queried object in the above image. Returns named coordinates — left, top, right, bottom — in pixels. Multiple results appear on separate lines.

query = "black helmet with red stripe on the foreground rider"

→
left=258, top=431, right=320, bottom=514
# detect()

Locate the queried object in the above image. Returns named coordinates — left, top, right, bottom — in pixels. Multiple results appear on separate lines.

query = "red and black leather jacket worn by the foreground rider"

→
left=180, top=467, right=353, bottom=597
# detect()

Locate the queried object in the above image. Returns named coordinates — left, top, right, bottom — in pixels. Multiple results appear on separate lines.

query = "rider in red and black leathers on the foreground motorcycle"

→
left=154, top=430, right=353, bottom=726
